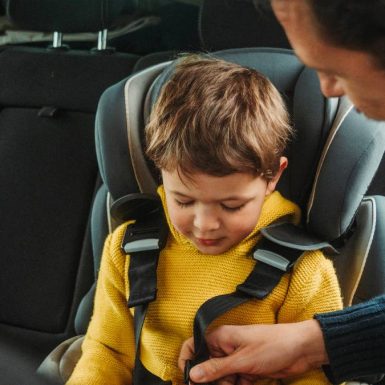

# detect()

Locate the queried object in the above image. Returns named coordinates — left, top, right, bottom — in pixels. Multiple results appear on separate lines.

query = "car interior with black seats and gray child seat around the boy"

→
left=0, top=0, right=385, bottom=384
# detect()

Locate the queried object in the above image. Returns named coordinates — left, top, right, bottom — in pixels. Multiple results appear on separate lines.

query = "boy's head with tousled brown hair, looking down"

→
left=146, top=56, right=291, bottom=254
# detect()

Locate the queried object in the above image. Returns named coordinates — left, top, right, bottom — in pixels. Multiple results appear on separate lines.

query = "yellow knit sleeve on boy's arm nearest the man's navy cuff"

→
left=277, top=251, right=342, bottom=385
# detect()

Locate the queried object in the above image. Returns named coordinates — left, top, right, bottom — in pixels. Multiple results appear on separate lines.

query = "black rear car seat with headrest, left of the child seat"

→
left=0, top=0, right=138, bottom=366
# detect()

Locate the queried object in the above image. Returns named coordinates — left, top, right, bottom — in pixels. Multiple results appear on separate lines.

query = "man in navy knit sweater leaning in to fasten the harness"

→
left=179, top=0, right=385, bottom=385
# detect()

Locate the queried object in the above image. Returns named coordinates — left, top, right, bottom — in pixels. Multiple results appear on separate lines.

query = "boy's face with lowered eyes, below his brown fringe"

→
left=162, top=158, right=287, bottom=255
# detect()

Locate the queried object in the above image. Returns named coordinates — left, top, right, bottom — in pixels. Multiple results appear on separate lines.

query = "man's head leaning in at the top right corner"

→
left=272, top=0, right=385, bottom=119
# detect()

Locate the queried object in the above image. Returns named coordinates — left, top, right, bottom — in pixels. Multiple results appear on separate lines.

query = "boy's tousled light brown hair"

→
left=146, top=55, right=292, bottom=180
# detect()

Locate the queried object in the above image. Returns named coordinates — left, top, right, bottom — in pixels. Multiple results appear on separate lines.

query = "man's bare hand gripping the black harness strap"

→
left=178, top=320, right=328, bottom=385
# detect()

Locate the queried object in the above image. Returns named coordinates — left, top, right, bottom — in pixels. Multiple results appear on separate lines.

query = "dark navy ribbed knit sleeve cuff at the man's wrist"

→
left=315, top=296, right=385, bottom=384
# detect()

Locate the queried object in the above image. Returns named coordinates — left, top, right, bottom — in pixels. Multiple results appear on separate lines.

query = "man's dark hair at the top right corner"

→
left=307, top=0, right=385, bottom=69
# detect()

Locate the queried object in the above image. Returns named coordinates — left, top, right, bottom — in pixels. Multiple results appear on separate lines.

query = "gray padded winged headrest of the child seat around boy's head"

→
left=96, top=48, right=385, bottom=241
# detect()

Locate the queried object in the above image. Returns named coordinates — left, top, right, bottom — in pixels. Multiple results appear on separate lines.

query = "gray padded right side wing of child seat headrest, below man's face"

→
left=308, top=114, right=385, bottom=241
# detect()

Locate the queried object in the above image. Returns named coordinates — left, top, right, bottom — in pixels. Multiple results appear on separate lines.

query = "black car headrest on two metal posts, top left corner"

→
left=3, top=0, right=125, bottom=33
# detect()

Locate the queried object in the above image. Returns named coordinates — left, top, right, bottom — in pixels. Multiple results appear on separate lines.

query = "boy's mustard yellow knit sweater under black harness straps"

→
left=67, top=188, right=342, bottom=385
